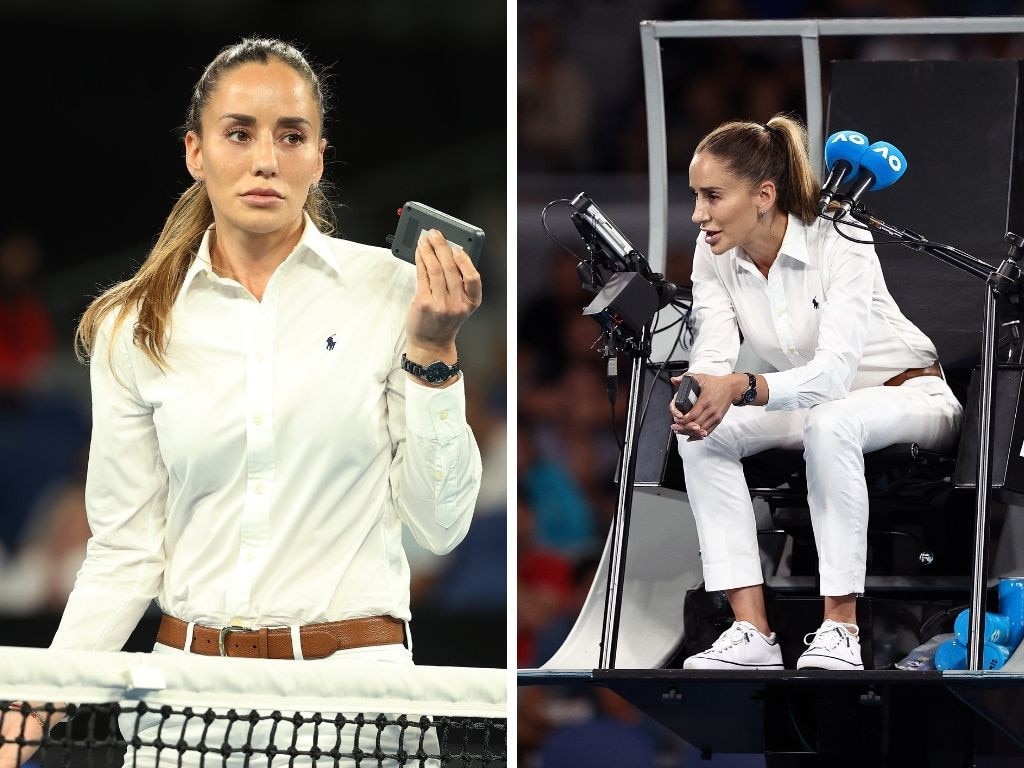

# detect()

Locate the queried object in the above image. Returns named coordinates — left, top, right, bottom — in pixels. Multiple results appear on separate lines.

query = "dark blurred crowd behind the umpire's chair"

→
left=516, top=0, right=1024, bottom=766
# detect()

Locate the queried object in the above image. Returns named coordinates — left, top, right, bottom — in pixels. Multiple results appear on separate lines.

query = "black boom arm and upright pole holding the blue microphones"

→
left=828, top=204, right=1024, bottom=672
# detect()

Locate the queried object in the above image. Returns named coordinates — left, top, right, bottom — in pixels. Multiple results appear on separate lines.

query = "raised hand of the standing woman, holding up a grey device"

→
left=407, top=229, right=483, bottom=357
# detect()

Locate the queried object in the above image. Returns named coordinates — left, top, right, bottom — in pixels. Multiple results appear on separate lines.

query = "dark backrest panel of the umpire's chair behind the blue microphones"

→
left=826, top=59, right=1024, bottom=376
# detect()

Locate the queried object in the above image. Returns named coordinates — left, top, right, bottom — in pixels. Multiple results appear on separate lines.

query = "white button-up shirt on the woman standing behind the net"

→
left=53, top=219, right=480, bottom=650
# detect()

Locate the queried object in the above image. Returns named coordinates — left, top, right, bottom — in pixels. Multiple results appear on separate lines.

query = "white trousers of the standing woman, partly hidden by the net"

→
left=118, top=643, right=440, bottom=768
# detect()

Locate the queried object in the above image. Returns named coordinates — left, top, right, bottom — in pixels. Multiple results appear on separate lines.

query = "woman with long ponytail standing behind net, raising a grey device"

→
left=0, top=38, right=481, bottom=766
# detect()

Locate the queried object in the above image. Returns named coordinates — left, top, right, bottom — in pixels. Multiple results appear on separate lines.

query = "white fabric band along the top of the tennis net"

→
left=0, top=647, right=507, bottom=718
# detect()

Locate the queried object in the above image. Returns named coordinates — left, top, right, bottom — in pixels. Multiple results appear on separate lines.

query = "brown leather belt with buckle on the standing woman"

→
left=157, top=613, right=406, bottom=658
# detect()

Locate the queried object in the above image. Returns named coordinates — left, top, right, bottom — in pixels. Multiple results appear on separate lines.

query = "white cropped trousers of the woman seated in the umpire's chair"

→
left=678, top=376, right=963, bottom=596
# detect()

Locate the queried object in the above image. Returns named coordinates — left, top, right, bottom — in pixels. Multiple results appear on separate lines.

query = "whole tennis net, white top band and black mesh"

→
left=0, top=647, right=507, bottom=768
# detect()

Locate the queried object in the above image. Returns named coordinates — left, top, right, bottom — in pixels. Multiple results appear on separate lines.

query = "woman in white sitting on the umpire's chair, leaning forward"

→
left=670, top=116, right=963, bottom=670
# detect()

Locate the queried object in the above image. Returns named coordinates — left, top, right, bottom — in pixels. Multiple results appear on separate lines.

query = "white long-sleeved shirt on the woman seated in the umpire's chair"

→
left=689, top=215, right=937, bottom=410
